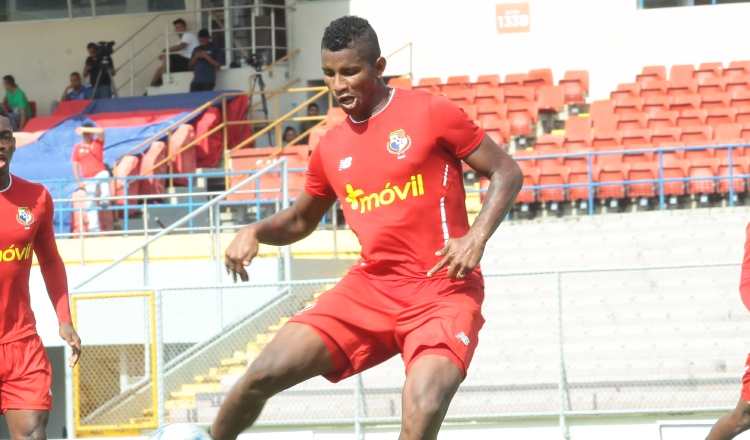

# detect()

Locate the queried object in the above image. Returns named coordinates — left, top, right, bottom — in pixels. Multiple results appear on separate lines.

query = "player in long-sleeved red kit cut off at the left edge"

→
left=0, top=106, right=81, bottom=440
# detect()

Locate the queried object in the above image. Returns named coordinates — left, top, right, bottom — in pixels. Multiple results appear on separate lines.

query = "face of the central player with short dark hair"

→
left=322, top=48, right=385, bottom=120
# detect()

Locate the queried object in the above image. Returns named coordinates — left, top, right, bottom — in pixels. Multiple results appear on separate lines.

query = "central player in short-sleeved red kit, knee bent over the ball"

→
left=210, top=16, right=523, bottom=440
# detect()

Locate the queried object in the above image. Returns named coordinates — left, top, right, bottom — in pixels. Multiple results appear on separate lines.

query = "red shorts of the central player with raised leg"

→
left=290, top=272, right=484, bottom=382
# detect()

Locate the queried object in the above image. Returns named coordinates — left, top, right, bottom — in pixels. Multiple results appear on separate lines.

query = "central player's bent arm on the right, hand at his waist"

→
left=427, top=135, right=523, bottom=278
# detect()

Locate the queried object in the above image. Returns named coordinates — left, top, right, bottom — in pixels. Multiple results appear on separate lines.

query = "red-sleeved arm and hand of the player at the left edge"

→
left=34, top=191, right=81, bottom=368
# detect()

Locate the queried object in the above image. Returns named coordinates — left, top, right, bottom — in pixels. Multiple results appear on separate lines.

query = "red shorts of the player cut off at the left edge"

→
left=0, top=335, right=52, bottom=414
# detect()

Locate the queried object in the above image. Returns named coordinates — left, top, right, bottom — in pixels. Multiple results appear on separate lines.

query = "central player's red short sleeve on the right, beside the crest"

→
left=428, top=95, right=485, bottom=158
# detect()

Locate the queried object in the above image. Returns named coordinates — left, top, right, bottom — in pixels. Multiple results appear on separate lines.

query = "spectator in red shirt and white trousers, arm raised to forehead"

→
left=70, top=123, right=110, bottom=232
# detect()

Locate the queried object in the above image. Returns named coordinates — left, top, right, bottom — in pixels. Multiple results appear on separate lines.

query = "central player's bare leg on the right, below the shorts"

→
left=399, top=355, right=461, bottom=440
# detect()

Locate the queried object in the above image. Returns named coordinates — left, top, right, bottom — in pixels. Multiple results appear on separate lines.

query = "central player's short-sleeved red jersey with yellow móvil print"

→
left=305, top=89, right=485, bottom=278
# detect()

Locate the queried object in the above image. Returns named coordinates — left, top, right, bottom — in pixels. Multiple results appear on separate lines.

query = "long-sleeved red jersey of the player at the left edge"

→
left=0, top=175, right=71, bottom=344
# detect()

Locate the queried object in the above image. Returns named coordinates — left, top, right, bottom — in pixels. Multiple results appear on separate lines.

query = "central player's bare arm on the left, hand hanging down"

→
left=225, top=191, right=336, bottom=282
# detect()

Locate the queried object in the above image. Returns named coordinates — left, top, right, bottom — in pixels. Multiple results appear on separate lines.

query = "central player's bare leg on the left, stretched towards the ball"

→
left=210, top=322, right=333, bottom=440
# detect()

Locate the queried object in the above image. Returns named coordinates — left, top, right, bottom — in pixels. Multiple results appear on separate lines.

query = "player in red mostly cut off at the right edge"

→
left=706, top=223, right=750, bottom=440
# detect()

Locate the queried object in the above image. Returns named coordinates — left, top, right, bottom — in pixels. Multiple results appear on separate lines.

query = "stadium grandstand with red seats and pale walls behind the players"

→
left=0, top=0, right=750, bottom=440
